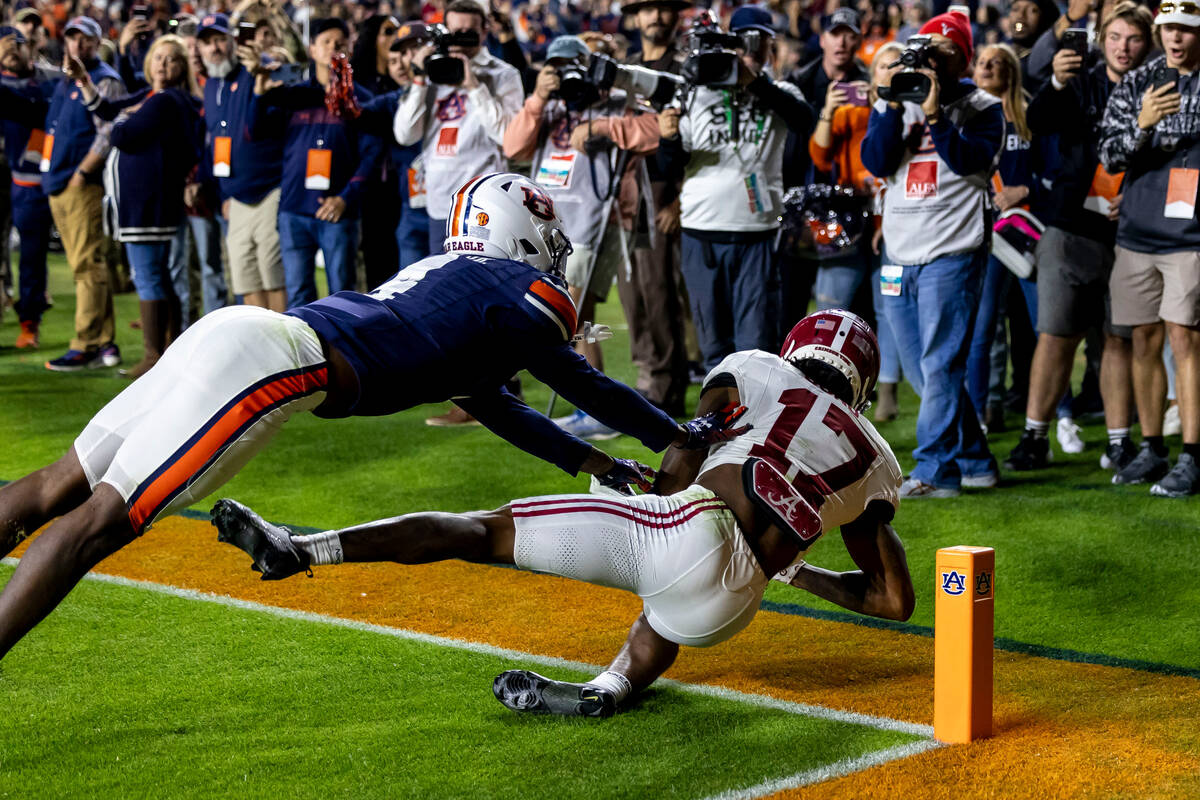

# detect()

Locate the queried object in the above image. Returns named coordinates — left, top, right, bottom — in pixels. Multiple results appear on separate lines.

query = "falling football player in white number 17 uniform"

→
left=214, top=311, right=914, bottom=716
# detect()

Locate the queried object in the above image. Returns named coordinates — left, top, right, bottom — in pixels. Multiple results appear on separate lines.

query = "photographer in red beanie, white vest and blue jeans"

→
left=863, top=13, right=1004, bottom=498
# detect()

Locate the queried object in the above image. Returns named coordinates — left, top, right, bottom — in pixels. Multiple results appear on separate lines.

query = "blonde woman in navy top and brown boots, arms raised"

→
left=64, top=36, right=204, bottom=379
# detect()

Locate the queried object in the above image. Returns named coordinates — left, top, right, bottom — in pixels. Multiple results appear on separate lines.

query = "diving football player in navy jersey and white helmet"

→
left=0, top=174, right=744, bottom=656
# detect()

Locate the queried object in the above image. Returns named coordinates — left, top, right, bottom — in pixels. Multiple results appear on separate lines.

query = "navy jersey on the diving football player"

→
left=287, top=254, right=678, bottom=474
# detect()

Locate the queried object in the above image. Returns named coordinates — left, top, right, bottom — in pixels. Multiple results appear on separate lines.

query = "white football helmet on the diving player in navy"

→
left=443, top=173, right=571, bottom=276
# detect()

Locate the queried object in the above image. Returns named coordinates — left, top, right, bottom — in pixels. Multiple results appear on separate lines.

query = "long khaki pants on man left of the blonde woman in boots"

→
left=50, top=184, right=114, bottom=350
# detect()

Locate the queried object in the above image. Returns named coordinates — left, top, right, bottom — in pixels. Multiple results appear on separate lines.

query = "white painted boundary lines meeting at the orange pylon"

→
left=0, top=558, right=944, bottom=800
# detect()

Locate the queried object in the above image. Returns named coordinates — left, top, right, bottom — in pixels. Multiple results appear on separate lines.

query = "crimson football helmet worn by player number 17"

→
left=779, top=308, right=880, bottom=411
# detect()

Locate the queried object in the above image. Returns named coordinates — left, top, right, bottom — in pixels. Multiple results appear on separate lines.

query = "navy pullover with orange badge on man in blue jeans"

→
left=251, top=78, right=383, bottom=219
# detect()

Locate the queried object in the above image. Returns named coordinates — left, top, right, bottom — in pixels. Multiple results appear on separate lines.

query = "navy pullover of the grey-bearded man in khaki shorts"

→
left=204, top=64, right=283, bottom=205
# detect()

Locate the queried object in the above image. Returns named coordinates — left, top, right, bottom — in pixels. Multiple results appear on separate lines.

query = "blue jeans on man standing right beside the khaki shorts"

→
left=280, top=211, right=359, bottom=308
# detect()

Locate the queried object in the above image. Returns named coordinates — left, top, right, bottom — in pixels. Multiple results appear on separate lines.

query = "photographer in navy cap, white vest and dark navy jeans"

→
left=658, top=6, right=814, bottom=369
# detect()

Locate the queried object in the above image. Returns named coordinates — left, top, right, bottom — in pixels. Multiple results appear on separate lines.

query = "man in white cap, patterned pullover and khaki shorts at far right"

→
left=1099, top=0, right=1200, bottom=498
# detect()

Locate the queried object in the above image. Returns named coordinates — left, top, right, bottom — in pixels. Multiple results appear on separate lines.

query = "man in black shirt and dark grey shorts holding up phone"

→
left=1004, top=1, right=1153, bottom=470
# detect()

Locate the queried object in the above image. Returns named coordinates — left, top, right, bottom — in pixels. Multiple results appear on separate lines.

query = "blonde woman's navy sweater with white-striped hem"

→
left=92, top=89, right=204, bottom=242
